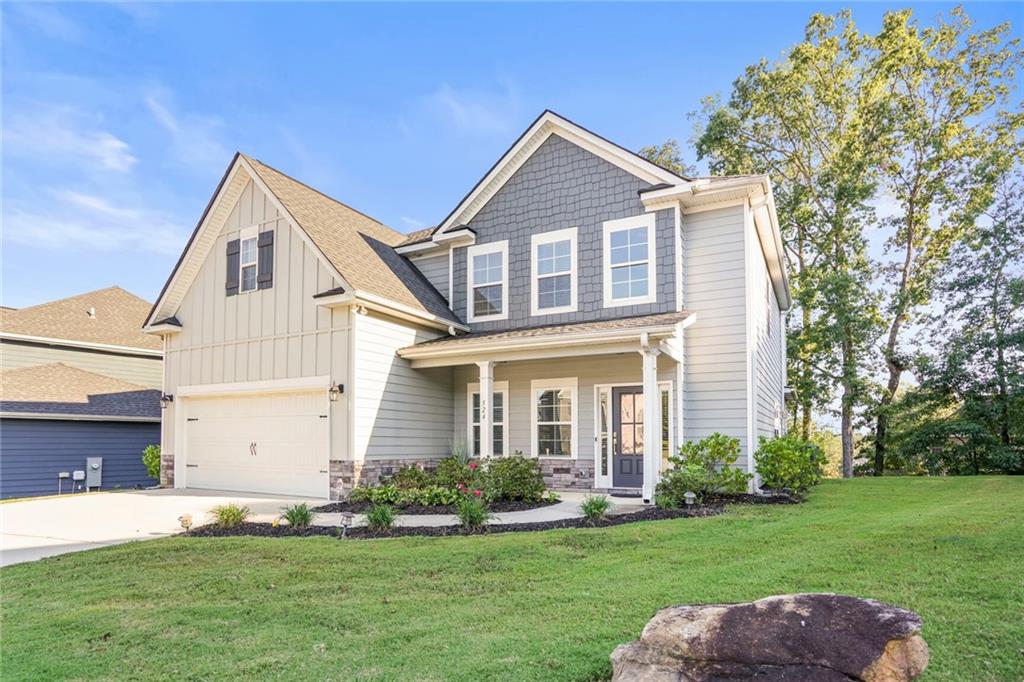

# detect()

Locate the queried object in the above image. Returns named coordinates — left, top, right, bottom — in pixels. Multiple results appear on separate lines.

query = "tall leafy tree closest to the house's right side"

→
left=697, top=11, right=888, bottom=476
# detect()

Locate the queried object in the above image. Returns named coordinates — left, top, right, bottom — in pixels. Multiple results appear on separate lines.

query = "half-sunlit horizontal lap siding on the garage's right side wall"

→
left=352, top=311, right=452, bottom=460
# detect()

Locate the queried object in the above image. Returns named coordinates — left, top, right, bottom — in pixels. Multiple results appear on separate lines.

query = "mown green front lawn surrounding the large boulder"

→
left=0, top=477, right=1024, bottom=681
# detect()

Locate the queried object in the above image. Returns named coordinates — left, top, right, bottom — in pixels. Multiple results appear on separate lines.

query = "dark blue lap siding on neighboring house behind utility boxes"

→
left=0, top=419, right=160, bottom=499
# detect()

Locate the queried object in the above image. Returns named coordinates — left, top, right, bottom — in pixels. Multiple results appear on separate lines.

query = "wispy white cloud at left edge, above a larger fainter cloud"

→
left=3, top=104, right=138, bottom=173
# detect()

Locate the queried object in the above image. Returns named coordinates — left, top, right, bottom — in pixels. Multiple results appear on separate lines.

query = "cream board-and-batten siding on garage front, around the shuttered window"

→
left=163, top=175, right=349, bottom=460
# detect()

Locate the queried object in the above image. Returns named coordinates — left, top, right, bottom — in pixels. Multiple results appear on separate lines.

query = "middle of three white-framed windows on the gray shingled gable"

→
left=530, top=227, right=577, bottom=315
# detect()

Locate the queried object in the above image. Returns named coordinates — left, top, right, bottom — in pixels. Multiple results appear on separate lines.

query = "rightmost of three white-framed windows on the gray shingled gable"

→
left=603, top=213, right=657, bottom=307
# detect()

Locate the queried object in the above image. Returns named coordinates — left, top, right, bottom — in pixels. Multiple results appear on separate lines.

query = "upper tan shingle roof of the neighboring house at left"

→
left=0, top=287, right=163, bottom=350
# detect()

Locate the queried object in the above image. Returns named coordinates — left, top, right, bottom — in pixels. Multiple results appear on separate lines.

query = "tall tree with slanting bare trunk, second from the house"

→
left=873, top=8, right=1022, bottom=475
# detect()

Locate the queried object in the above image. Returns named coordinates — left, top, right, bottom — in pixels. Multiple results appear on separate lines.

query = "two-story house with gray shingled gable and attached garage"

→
left=146, top=112, right=790, bottom=500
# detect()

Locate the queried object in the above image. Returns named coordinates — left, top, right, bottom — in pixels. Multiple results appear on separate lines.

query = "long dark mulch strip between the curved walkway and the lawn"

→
left=186, top=505, right=724, bottom=540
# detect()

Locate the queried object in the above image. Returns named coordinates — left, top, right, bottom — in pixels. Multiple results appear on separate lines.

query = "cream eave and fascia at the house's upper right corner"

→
left=640, top=175, right=793, bottom=310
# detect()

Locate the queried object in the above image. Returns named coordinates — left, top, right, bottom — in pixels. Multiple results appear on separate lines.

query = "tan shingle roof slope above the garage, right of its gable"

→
left=245, top=157, right=461, bottom=322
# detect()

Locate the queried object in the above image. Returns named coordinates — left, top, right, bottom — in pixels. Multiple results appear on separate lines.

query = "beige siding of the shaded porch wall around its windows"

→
left=452, top=352, right=678, bottom=461
